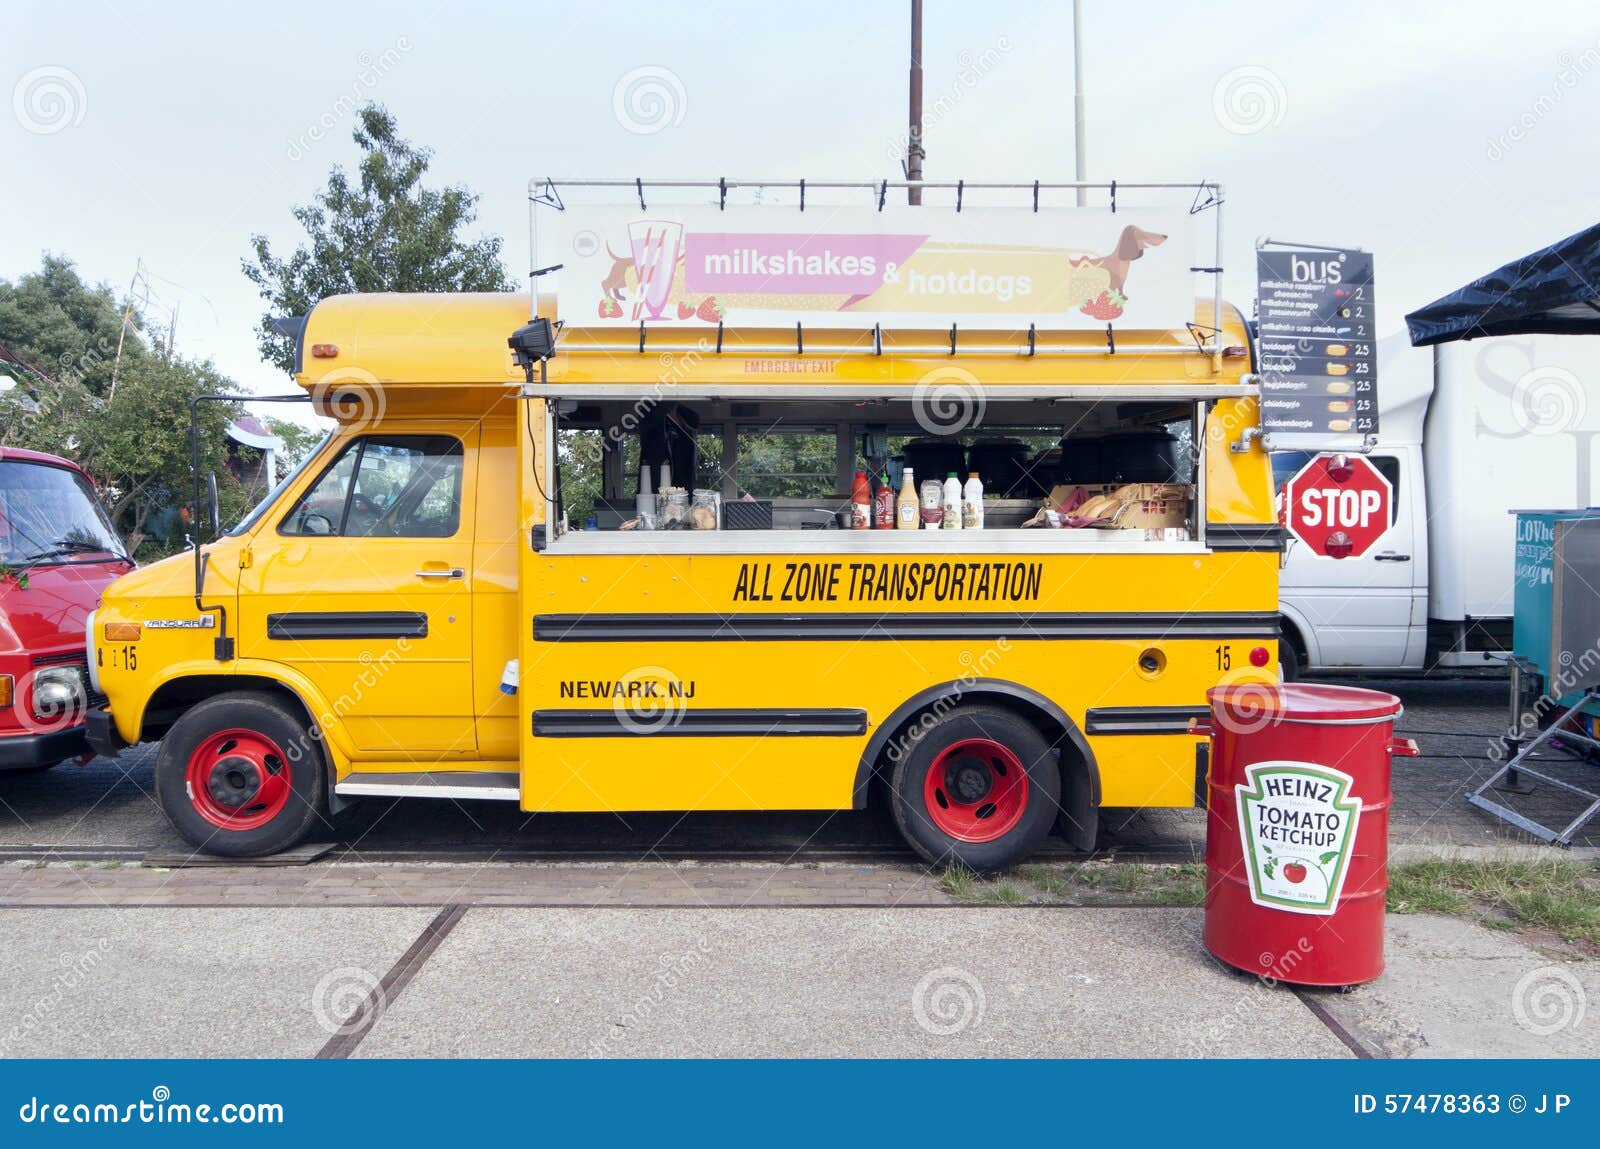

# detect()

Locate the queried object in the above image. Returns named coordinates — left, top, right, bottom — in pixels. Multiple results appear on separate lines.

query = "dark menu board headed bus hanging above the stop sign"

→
left=1256, top=248, right=1378, bottom=442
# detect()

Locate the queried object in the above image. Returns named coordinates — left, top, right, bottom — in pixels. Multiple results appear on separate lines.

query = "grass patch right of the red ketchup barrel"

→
left=1389, top=858, right=1600, bottom=946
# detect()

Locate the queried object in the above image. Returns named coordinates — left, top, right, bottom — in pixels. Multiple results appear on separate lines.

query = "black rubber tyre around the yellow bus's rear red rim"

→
left=890, top=706, right=1061, bottom=872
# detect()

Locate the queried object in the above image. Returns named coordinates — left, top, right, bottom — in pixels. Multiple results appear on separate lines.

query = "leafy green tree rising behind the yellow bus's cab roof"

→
left=242, top=104, right=515, bottom=374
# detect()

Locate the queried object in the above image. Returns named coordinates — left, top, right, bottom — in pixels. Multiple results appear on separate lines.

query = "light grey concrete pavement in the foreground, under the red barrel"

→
left=0, top=903, right=1600, bottom=1058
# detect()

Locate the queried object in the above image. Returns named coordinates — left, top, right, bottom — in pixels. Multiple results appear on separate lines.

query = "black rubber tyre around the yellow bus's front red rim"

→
left=155, top=691, right=330, bottom=858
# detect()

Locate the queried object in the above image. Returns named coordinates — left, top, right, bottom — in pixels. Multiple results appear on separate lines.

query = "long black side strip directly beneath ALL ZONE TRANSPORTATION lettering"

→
left=533, top=611, right=1278, bottom=642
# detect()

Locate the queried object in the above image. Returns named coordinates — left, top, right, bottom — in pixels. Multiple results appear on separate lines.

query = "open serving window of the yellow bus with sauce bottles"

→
left=549, top=398, right=1205, bottom=552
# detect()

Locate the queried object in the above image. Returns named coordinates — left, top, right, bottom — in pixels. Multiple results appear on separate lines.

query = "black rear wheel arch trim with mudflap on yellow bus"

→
left=851, top=679, right=1101, bottom=850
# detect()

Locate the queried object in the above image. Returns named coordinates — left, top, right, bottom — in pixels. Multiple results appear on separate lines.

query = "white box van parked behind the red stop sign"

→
left=1272, top=333, right=1600, bottom=675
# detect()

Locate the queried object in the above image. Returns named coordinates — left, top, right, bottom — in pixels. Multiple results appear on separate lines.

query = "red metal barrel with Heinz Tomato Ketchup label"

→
left=1190, top=683, right=1418, bottom=986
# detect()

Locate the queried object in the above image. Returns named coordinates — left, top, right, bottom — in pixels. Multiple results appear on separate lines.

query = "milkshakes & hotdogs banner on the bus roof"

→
left=550, top=205, right=1195, bottom=331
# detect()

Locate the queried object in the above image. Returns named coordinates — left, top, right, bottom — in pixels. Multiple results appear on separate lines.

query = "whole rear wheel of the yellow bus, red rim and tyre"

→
left=890, top=706, right=1061, bottom=871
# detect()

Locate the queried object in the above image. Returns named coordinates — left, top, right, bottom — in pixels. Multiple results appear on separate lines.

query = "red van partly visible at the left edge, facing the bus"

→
left=0, top=446, right=133, bottom=771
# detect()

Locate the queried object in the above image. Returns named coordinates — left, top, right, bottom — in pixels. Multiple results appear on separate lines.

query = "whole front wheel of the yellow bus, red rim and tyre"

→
left=155, top=693, right=326, bottom=858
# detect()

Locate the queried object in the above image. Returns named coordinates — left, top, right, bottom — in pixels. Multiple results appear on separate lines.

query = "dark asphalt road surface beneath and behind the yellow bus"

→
left=0, top=682, right=1600, bottom=859
